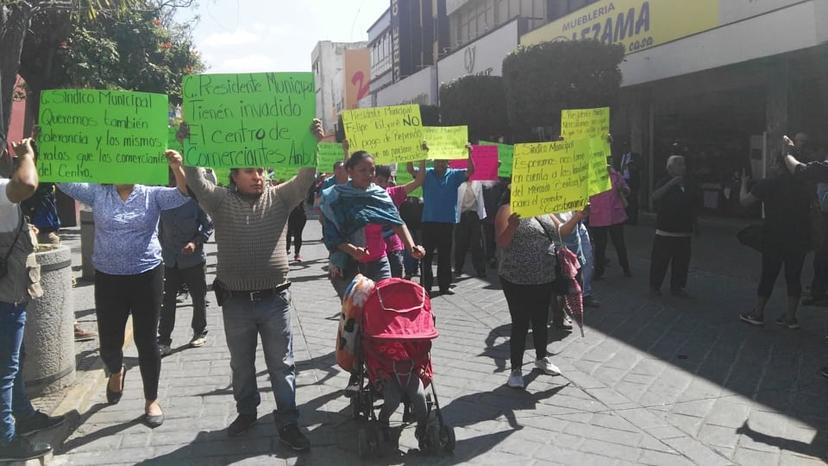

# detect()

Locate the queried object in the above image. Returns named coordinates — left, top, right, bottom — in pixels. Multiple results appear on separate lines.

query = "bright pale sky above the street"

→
left=179, top=0, right=390, bottom=73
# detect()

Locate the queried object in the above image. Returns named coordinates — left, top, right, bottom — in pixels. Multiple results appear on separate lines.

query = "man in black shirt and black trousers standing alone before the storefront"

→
left=650, top=155, right=700, bottom=297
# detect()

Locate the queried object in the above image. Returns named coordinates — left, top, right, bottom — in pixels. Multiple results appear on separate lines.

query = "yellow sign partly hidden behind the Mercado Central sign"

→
left=561, top=107, right=612, bottom=196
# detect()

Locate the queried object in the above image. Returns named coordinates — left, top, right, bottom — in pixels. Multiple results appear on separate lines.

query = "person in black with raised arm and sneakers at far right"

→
left=739, top=161, right=813, bottom=329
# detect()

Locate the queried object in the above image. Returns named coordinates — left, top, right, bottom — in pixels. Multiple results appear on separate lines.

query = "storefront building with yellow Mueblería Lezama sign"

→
left=521, top=0, right=828, bottom=216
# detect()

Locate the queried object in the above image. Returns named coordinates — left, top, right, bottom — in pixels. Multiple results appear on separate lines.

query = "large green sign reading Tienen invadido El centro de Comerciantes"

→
left=184, top=73, right=316, bottom=176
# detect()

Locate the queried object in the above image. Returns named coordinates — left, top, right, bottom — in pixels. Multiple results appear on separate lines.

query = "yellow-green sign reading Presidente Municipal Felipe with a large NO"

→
left=342, top=105, right=423, bottom=165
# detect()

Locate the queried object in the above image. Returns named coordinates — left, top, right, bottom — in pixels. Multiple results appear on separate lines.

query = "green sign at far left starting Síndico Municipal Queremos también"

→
left=37, top=89, right=169, bottom=185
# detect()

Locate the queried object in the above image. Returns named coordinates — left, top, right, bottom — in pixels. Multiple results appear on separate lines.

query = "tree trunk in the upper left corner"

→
left=0, top=2, right=33, bottom=142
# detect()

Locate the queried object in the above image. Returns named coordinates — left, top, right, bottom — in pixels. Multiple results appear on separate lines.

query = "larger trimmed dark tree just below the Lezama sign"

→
left=503, top=40, right=624, bottom=140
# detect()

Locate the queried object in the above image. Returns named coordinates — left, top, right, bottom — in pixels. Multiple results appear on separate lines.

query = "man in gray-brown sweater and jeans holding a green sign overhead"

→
left=185, top=120, right=324, bottom=451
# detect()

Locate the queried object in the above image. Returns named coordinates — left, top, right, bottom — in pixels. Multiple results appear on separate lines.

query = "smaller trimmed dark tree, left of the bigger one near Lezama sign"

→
left=440, top=76, right=509, bottom=141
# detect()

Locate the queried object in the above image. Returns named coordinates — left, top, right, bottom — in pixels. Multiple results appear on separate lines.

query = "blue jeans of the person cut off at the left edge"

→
left=0, top=302, right=34, bottom=445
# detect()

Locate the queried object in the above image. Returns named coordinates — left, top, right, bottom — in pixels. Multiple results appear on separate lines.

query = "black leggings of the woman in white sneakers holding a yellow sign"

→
left=500, top=277, right=552, bottom=370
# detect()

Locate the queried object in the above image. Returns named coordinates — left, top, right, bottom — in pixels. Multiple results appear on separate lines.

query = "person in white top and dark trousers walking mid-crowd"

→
left=454, top=180, right=486, bottom=278
